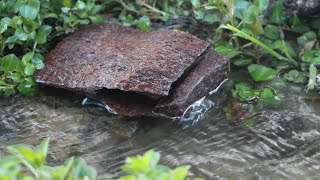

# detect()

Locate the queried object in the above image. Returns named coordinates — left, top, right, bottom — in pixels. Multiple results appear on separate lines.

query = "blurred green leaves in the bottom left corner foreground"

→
left=0, top=138, right=97, bottom=180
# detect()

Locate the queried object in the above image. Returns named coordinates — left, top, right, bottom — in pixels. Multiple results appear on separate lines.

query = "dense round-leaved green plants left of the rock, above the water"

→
left=0, top=0, right=103, bottom=97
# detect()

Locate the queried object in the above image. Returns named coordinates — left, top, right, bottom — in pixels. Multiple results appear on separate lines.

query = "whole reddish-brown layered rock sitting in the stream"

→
left=35, top=24, right=229, bottom=117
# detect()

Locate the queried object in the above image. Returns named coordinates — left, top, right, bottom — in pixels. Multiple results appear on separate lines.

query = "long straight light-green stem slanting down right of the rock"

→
left=227, top=24, right=298, bottom=65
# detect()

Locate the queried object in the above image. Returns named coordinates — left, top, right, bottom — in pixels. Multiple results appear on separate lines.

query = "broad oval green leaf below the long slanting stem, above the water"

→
left=248, top=64, right=277, bottom=81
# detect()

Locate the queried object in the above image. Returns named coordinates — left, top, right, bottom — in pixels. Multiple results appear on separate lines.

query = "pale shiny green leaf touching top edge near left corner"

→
left=19, top=0, right=40, bottom=19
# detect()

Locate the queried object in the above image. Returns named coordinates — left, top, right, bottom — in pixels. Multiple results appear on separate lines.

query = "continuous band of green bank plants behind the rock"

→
left=0, top=0, right=320, bottom=100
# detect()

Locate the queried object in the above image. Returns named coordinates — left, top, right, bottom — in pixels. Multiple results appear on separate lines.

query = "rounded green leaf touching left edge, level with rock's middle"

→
left=0, top=54, right=23, bottom=73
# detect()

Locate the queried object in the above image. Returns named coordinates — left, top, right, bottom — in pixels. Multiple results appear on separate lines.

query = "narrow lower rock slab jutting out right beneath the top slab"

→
left=154, top=50, right=229, bottom=117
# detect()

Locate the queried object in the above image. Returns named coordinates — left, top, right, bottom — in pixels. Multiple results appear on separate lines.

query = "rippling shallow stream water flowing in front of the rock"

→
left=0, top=72, right=320, bottom=179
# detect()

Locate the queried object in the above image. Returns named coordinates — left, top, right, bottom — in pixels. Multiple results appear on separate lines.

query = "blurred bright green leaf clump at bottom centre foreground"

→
left=120, top=150, right=190, bottom=180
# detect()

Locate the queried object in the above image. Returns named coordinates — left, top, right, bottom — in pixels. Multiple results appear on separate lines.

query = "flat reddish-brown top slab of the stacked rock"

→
left=35, top=24, right=210, bottom=99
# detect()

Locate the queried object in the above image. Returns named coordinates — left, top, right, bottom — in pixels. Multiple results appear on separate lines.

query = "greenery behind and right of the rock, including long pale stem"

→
left=105, top=0, right=320, bottom=96
